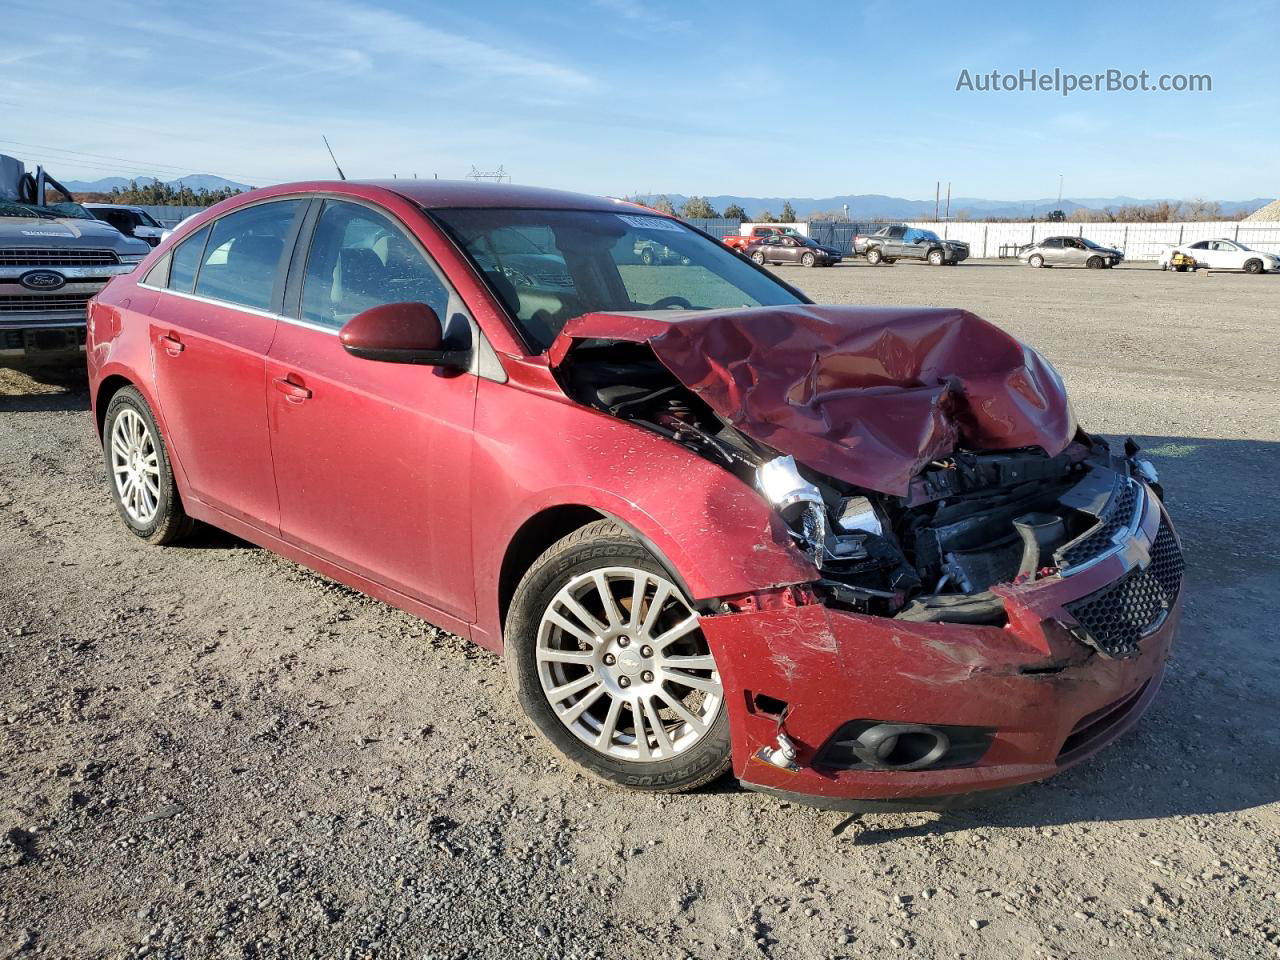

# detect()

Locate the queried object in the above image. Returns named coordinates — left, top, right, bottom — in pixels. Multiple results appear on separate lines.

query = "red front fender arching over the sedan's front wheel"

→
left=472, top=381, right=819, bottom=647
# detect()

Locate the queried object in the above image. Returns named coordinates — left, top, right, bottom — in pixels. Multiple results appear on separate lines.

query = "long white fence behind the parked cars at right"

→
left=911, top=220, right=1280, bottom=260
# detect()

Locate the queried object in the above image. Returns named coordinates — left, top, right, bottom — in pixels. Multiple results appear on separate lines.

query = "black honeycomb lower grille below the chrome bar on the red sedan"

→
left=1062, top=521, right=1185, bottom=659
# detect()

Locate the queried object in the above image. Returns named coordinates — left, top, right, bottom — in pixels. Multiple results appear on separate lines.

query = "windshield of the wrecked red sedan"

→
left=431, top=210, right=804, bottom=351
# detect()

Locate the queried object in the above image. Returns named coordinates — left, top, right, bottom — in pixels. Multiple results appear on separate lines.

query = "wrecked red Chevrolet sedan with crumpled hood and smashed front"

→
left=87, top=180, right=1183, bottom=809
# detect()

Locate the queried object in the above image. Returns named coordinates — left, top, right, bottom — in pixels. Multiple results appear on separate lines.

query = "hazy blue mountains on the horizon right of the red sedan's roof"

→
left=640, top=193, right=1271, bottom=220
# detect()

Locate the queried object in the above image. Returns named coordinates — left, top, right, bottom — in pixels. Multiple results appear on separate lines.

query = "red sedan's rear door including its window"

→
left=147, top=200, right=305, bottom=532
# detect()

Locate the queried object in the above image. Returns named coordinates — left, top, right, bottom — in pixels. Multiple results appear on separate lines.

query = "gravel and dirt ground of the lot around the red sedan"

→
left=0, top=262, right=1280, bottom=960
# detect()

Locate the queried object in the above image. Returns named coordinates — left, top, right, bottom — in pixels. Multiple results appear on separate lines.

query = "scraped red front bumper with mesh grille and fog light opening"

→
left=703, top=494, right=1183, bottom=809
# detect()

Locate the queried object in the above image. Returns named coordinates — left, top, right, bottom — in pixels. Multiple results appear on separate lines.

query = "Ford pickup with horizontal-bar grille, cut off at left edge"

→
left=0, top=155, right=151, bottom=364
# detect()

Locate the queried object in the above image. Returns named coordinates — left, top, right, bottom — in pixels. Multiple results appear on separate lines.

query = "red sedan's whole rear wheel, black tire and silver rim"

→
left=102, top=387, right=195, bottom=545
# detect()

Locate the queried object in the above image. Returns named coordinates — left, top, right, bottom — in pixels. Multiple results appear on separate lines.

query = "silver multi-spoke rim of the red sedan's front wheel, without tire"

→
left=536, top=567, right=723, bottom=763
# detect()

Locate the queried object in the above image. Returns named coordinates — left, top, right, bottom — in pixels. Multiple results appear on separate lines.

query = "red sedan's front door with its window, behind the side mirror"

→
left=268, top=200, right=477, bottom=621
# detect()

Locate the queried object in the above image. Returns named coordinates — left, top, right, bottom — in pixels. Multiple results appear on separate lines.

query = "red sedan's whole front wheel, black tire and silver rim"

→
left=504, top=520, right=731, bottom=792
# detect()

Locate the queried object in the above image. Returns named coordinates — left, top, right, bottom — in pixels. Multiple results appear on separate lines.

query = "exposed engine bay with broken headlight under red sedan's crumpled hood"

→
left=558, top=339, right=1158, bottom=625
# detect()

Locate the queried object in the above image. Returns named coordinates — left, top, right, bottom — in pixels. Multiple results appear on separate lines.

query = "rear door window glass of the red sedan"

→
left=193, top=200, right=302, bottom=310
